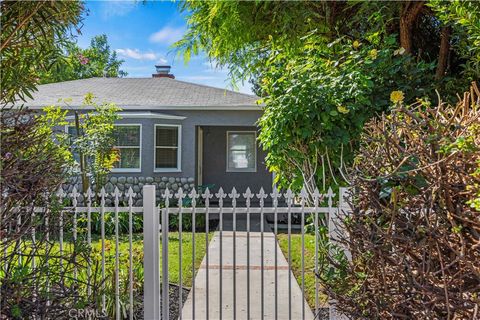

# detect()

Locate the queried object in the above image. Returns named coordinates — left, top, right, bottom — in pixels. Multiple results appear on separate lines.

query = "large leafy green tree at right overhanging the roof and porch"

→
left=175, top=1, right=480, bottom=192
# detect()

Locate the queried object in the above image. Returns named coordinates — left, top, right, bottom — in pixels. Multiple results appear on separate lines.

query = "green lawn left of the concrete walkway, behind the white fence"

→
left=0, top=232, right=213, bottom=318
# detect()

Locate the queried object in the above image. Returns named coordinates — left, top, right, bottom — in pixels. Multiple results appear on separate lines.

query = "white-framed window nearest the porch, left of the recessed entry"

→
left=155, top=124, right=181, bottom=172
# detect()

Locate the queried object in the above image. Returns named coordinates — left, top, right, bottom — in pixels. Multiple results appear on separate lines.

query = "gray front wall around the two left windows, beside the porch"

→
left=60, top=109, right=268, bottom=205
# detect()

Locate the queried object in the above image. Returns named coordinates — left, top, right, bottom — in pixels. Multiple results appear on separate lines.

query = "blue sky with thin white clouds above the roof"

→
left=77, top=1, right=252, bottom=94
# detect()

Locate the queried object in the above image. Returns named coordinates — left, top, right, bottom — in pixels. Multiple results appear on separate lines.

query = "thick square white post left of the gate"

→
left=143, top=185, right=160, bottom=320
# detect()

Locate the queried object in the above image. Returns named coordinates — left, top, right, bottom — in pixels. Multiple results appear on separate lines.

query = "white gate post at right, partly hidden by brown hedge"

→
left=328, top=187, right=351, bottom=320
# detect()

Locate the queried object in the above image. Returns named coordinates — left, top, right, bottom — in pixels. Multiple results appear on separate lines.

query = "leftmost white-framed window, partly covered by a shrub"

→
left=113, top=124, right=141, bottom=172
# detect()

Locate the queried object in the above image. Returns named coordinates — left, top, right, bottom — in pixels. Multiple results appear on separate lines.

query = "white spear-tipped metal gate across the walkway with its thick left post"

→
left=143, top=186, right=348, bottom=319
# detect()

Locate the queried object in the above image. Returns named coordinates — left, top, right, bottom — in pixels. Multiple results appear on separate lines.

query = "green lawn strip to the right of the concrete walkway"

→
left=278, top=234, right=326, bottom=310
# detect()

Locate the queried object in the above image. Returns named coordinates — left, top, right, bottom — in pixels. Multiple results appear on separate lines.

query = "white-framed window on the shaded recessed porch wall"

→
left=227, top=131, right=257, bottom=172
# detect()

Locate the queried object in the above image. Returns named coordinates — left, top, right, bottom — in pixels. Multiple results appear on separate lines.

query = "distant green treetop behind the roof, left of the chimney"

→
left=40, top=34, right=127, bottom=83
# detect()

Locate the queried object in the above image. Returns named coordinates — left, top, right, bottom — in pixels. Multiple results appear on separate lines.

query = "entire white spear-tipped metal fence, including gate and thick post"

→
left=7, top=185, right=349, bottom=320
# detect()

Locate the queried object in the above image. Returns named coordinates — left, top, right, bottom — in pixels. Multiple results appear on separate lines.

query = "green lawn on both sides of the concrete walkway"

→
left=5, top=232, right=326, bottom=316
